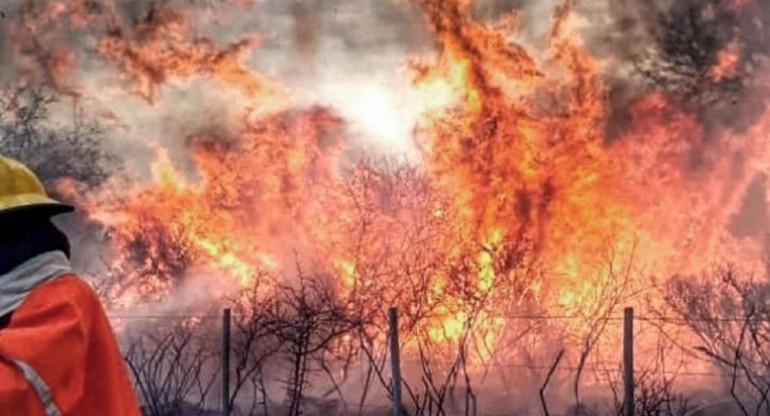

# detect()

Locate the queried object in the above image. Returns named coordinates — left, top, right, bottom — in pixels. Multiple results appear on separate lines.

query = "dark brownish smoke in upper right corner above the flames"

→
left=594, top=0, right=770, bottom=252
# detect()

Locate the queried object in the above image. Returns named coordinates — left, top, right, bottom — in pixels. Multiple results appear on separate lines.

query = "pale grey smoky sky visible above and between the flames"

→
left=0, top=0, right=770, bottom=159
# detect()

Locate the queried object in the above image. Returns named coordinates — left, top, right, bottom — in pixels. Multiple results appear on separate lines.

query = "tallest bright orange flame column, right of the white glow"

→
left=415, top=2, right=620, bottom=310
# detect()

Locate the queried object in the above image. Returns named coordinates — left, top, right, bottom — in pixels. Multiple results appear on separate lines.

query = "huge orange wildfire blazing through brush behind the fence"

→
left=7, top=0, right=770, bottom=370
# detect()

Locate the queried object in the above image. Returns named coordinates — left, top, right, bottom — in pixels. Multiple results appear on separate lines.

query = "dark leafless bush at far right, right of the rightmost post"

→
left=665, top=266, right=770, bottom=415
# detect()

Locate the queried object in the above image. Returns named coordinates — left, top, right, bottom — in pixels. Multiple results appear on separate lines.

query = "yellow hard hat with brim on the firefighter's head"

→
left=0, top=155, right=73, bottom=216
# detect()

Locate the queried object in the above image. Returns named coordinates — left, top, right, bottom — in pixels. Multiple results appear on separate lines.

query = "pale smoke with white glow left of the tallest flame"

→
left=0, top=0, right=430, bottom=176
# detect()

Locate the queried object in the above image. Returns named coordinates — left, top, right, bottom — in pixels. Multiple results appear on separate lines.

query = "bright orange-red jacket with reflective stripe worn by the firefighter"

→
left=0, top=275, right=141, bottom=416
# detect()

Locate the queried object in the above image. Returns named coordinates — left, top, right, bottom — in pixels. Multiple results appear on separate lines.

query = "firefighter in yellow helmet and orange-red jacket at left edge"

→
left=0, top=155, right=141, bottom=416
